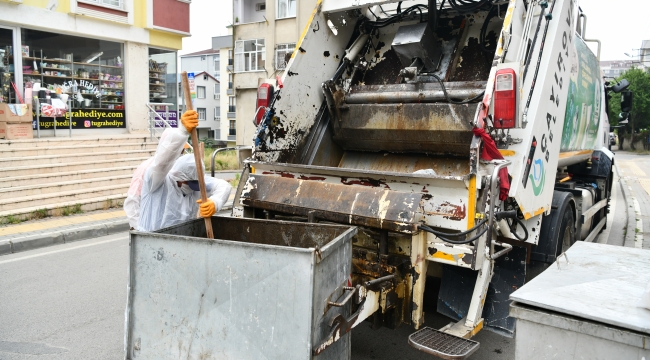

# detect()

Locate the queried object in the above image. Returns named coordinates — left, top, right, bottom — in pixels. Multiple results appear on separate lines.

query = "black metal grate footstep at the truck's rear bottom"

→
left=409, top=327, right=480, bottom=359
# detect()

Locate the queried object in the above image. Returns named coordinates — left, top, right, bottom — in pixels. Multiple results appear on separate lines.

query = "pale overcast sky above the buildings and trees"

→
left=180, top=0, right=650, bottom=60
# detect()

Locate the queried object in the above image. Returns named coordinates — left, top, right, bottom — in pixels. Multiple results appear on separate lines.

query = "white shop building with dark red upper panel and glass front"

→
left=0, top=0, right=190, bottom=136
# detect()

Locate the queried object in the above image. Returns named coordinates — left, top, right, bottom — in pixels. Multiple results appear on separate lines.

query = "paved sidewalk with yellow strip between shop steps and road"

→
left=0, top=194, right=234, bottom=256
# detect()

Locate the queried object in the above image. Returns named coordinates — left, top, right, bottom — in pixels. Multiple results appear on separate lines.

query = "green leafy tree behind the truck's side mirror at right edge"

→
left=608, top=68, right=650, bottom=149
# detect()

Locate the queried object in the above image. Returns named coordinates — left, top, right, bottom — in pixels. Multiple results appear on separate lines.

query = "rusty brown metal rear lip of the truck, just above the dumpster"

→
left=242, top=175, right=422, bottom=233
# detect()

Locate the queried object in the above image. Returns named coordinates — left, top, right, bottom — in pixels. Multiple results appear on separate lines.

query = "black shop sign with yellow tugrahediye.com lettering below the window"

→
left=32, top=109, right=126, bottom=130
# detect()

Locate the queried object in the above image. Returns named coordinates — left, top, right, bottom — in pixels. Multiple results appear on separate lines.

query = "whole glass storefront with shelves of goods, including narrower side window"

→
left=0, top=25, right=178, bottom=135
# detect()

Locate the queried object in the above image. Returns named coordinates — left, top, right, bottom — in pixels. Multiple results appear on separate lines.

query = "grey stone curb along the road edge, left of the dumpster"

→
left=0, top=218, right=129, bottom=256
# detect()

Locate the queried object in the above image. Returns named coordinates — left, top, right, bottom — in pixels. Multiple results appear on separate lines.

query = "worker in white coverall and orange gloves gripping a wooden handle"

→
left=136, top=110, right=232, bottom=231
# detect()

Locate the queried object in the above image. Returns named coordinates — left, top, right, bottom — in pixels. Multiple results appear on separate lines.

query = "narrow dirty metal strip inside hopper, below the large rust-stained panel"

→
left=339, top=151, right=469, bottom=176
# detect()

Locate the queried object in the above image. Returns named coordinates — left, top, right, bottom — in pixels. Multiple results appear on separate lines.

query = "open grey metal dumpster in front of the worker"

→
left=125, top=217, right=357, bottom=360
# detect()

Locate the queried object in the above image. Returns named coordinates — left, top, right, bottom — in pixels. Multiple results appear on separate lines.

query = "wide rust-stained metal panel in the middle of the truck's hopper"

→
left=333, top=104, right=478, bottom=156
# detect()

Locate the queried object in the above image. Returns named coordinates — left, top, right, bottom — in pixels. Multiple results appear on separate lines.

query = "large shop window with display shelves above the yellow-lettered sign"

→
left=20, top=29, right=127, bottom=129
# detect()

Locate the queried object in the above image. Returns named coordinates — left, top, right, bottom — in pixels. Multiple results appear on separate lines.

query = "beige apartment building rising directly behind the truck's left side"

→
left=231, top=0, right=316, bottom=146
